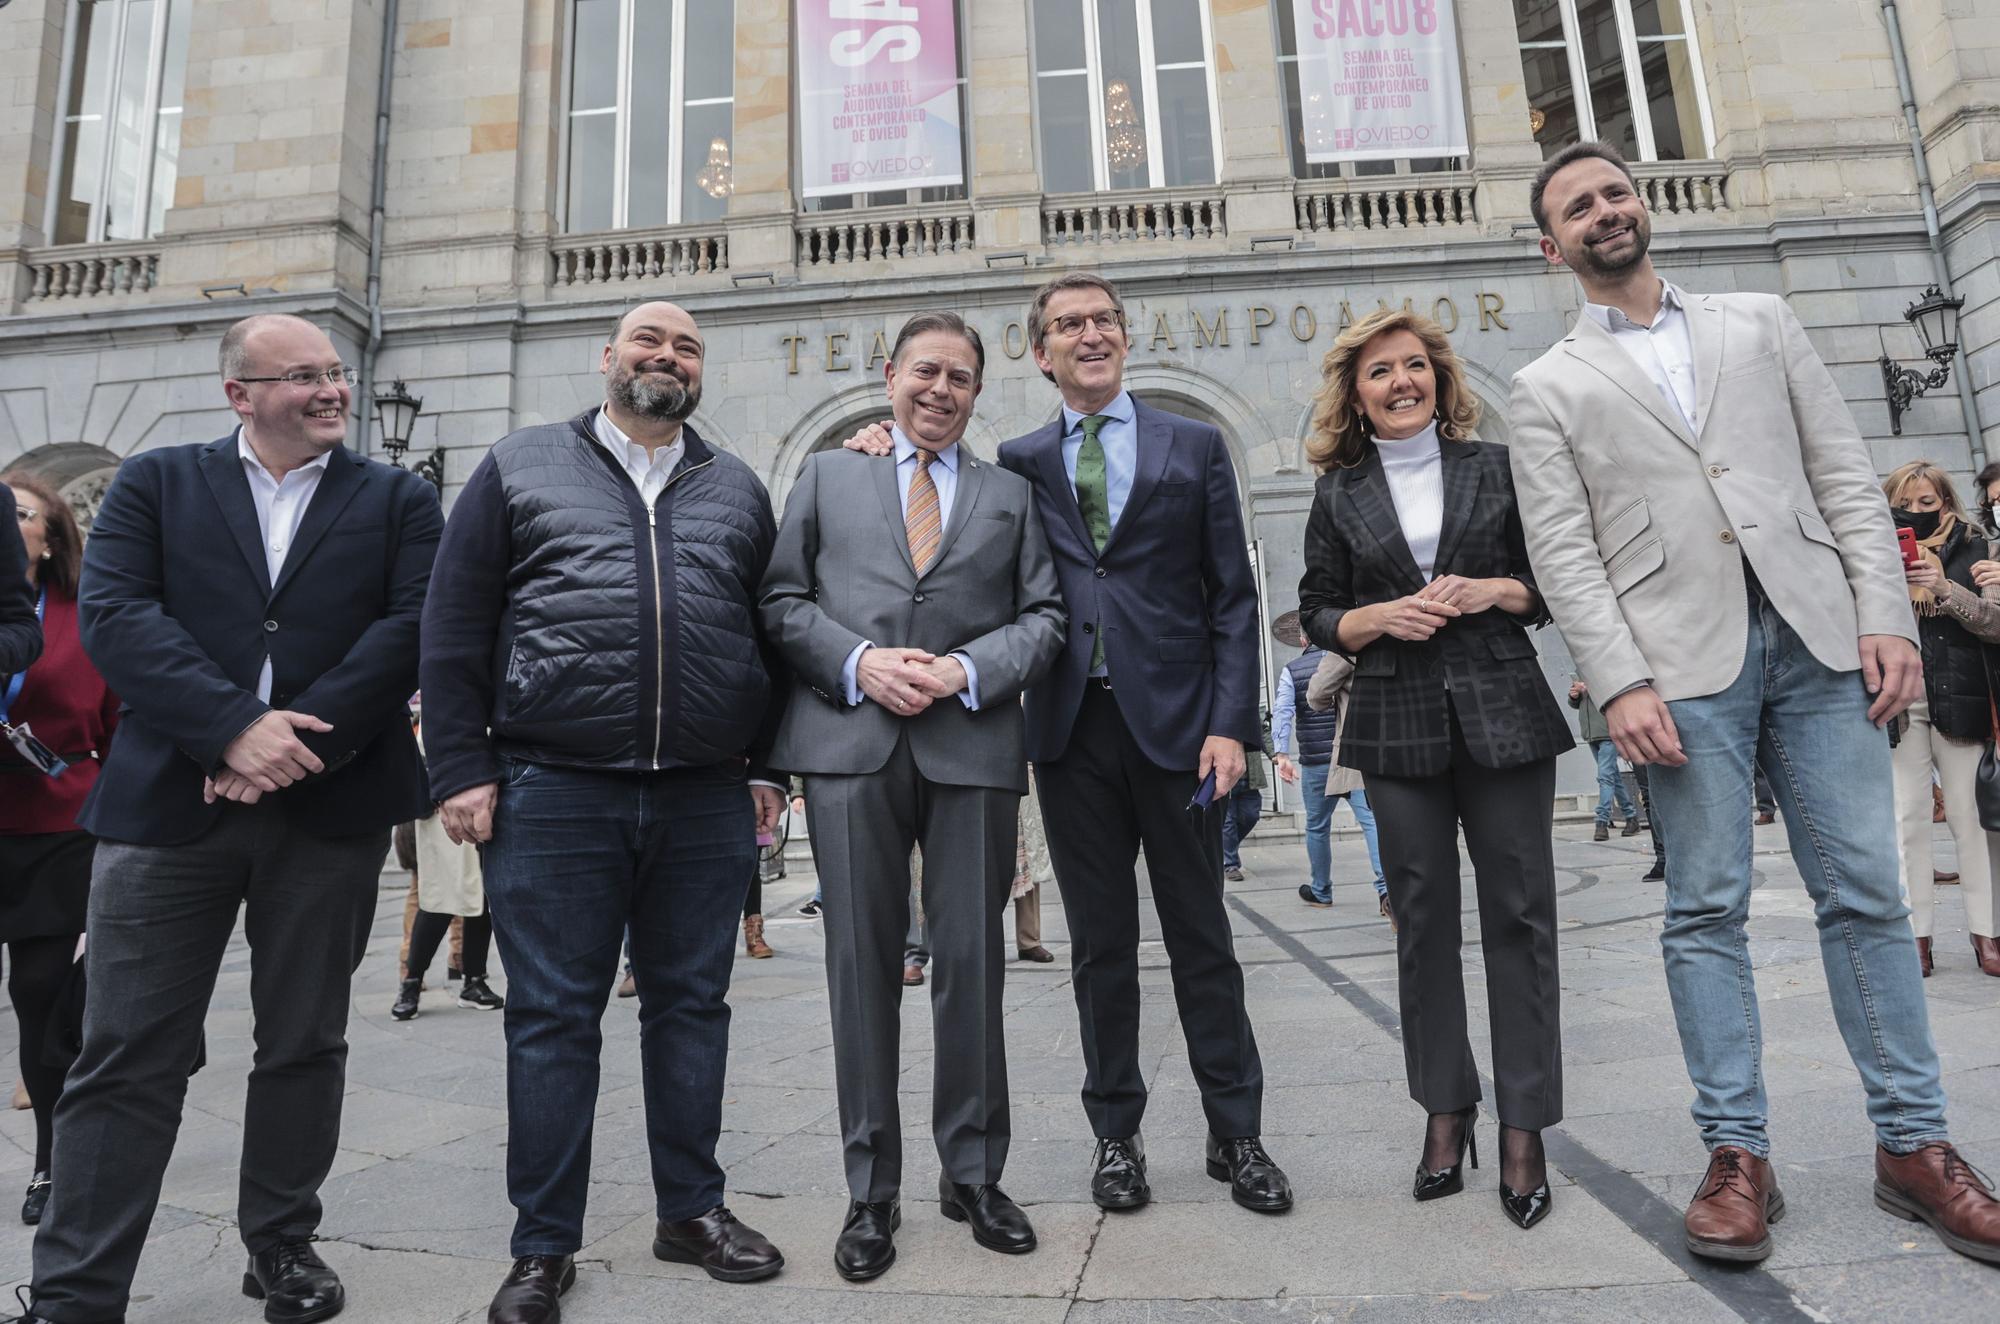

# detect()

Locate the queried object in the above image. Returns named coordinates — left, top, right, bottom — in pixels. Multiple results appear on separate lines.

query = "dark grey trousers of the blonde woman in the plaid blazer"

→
left=1366, top=722, right=1562, bottom=1130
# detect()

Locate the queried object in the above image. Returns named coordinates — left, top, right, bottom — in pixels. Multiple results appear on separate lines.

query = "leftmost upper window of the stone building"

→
left=46, top=0, right=194, bottom=244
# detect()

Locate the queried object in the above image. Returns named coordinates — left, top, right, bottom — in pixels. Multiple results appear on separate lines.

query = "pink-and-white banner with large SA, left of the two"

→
left=798, top=0, right=966, bottom=198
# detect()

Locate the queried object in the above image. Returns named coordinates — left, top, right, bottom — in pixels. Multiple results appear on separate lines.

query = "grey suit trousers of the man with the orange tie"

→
left=806, top=740, right=1020, bottom=1200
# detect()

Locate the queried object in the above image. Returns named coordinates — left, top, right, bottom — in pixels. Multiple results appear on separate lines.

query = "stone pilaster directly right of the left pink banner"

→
left=962, top=0, right=1042, bottom=262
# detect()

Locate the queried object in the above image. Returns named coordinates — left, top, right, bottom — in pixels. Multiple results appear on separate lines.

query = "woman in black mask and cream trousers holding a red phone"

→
left=1882, top=460, right=2000, bottom=978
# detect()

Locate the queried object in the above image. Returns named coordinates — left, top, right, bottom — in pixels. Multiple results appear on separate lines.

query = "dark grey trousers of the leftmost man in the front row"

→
left=34, top=796, right=388, bottom=1324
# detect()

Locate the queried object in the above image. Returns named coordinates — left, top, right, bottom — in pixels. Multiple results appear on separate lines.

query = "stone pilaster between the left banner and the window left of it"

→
left=728, top=0, right=796, bottom=276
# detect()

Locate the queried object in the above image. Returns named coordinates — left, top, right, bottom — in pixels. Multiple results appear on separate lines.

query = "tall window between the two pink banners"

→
left=1032, top=0, right=1222, bottom=194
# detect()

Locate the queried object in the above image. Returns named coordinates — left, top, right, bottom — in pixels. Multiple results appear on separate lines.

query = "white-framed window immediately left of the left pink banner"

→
left=562, top=0, right=736, bottom=232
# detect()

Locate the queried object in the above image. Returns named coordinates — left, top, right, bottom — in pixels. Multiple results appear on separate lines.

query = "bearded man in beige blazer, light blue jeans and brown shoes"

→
left=1510, top=142, right=2000, bottom=1262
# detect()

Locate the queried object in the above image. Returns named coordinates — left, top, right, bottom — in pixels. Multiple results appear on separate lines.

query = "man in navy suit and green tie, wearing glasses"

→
left=854, top=272, right=1292, bottom=1214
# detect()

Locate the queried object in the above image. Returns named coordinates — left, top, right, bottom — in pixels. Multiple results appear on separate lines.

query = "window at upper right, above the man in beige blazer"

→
left=1514, top=0, right=1716, bottom=160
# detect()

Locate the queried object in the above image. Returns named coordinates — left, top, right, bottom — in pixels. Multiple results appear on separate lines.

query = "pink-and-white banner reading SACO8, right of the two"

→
left=1292, top=0, right=1468, bottom=164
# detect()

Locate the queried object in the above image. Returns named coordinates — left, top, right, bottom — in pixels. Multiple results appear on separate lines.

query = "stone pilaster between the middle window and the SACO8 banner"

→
left=1210, top=0, right=1298, bottom=248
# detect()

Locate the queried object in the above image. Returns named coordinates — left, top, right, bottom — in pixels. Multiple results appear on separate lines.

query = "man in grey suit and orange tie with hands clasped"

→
left=760, top=312, right=1064, bottom=1282
